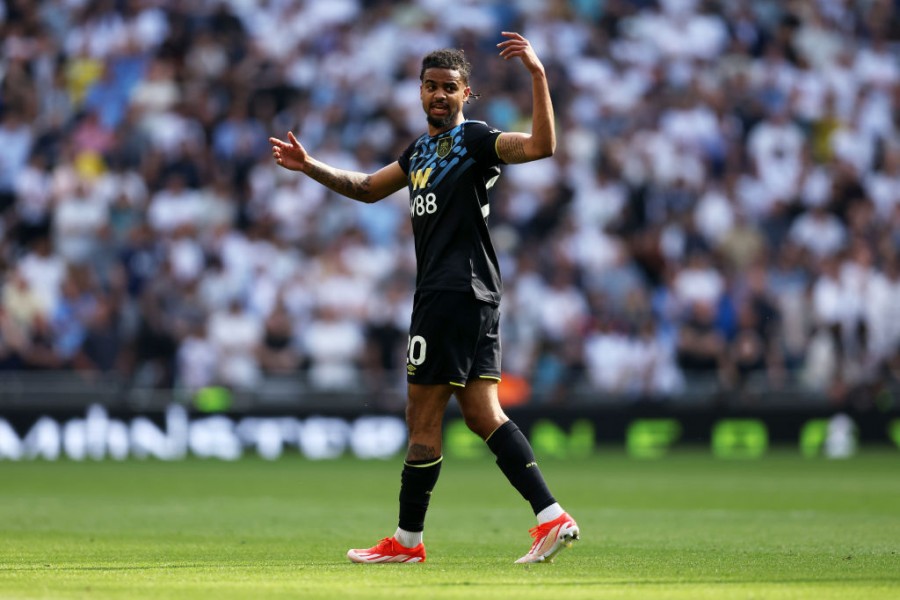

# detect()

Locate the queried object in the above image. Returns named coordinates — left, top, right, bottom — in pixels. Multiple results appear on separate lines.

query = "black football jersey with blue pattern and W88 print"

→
left=398, top=121, right=503, bottom=304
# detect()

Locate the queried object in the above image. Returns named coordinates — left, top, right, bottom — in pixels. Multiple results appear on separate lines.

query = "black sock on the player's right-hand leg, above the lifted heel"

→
left=487, top=421, right=556, bottom=514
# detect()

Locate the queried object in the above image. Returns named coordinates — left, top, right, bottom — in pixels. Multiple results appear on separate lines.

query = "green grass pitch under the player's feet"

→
left=0, top=449, right=900, bottom=600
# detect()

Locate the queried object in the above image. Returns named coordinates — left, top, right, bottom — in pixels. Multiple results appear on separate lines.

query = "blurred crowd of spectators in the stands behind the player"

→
left=0, top=0, right=900, bottom=402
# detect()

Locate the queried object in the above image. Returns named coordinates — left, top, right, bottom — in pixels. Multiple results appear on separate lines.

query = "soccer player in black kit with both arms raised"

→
left=269, top=32, right=579, bottom=563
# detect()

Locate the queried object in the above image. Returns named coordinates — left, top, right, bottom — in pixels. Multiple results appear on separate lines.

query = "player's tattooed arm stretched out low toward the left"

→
left=269, top=131, right=406, bottom=203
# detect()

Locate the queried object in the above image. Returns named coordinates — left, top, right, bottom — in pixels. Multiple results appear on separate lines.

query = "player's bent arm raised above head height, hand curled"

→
left=497, top=31, right=556, bottom=164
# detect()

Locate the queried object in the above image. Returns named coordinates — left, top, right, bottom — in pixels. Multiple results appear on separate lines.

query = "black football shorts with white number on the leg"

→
left=406, top=291, right=500, bottom=387
